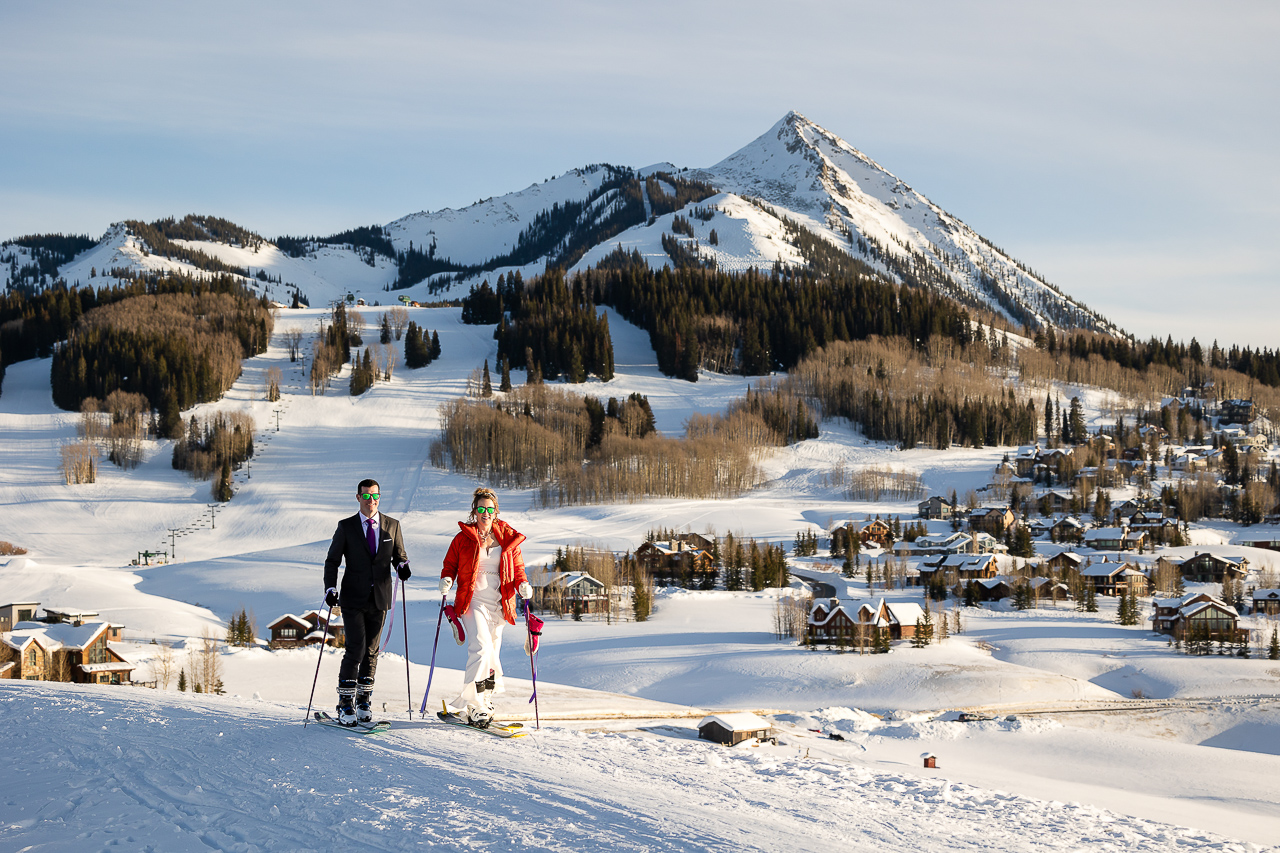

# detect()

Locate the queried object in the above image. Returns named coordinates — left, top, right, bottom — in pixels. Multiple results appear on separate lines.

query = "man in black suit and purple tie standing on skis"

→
left=324, top=480, right=410, bottom=726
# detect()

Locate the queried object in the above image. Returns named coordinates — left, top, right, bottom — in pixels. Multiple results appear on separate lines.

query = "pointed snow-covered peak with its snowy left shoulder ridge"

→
left=376, top=113, right=1117, bottom=333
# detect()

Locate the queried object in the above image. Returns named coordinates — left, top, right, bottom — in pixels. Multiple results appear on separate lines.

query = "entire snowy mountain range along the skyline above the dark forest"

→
left=0, top=113, right=1117, bottom=333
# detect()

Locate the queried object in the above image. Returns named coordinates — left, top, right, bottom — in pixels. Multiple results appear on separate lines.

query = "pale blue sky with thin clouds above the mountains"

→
left=0, top=0, right=1280, bottom=348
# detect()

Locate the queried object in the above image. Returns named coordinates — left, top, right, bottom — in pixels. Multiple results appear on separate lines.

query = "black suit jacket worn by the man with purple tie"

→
left=324, top=512, right=408, bottom=610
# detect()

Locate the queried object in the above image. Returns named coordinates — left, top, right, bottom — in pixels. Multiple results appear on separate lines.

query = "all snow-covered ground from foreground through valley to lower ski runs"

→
left=0, top=308, right=1280, bottom=852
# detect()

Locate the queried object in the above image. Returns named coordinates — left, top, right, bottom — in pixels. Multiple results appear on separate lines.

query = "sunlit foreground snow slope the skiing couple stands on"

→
left=0, top=684, right=1262, bottom=853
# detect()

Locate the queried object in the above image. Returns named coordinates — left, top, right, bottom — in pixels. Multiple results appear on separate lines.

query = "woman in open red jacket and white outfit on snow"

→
left=440, top=488, right=532, bottom=727
